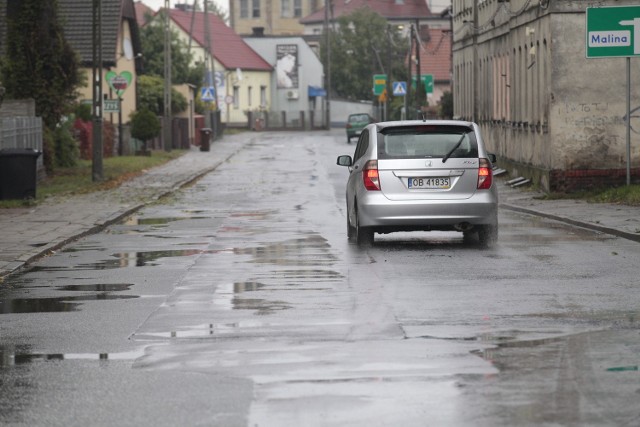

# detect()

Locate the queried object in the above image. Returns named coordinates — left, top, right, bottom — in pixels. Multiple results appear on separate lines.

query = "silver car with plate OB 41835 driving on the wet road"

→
left=337, top=120, right=498, bottom=247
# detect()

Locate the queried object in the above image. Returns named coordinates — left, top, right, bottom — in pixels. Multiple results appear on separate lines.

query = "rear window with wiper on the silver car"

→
left=378, top=125, right=478, bottom=159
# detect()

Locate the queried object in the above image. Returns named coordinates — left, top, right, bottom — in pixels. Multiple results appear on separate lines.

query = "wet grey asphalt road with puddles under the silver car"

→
left=0, top=133, right=640, bottom=427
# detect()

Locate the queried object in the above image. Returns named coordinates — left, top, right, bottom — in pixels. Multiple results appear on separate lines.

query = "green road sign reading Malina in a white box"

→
left=586, top=6, right=640, bottom=58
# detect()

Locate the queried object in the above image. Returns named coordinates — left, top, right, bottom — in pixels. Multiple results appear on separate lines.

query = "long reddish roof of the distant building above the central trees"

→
left=300, top=0, right=433, bottom=24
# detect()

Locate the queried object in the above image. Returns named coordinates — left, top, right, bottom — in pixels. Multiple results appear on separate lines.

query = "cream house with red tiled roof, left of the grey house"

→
left=169, top=7, right=273, bottom=126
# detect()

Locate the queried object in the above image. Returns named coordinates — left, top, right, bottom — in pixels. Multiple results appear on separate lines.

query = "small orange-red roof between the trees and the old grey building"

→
left=414, top=27, right=451, bottom=80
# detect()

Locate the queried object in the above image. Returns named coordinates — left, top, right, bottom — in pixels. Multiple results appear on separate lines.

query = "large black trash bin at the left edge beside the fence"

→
left=0, top=148, right=41, bottom=200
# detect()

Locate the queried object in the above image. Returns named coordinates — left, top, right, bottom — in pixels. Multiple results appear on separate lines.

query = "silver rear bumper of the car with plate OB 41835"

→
left=358, top=191, right=498, bottom=230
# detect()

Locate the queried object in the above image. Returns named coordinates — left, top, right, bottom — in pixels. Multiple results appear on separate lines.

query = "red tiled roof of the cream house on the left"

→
left=170, top=9, right=273, bottom=71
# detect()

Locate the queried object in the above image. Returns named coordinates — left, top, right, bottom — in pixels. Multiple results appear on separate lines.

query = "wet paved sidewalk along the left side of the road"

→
left=0, top=134, right=256, bottom=284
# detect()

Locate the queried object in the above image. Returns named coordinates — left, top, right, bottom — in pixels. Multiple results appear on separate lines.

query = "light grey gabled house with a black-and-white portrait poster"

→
left=244, top=36, right=326, bottom=128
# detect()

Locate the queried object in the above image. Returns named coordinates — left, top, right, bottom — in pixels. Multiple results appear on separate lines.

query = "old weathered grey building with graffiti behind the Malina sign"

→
left=453, top=0, right=640, bottom=191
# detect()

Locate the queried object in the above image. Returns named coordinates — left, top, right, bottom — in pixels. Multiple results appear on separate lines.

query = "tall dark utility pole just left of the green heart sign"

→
left=91, top=0, right=103, bottom=182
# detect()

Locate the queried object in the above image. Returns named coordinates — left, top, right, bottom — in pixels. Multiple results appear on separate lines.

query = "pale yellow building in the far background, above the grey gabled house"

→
left=229, top=0, right=324, bottom=36
